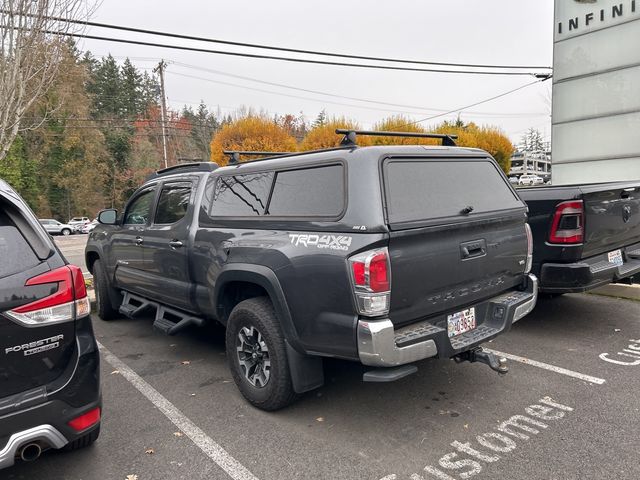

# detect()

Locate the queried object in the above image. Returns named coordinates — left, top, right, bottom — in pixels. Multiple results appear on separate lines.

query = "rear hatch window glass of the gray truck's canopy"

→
left=384, top=159, right=523, bottom=224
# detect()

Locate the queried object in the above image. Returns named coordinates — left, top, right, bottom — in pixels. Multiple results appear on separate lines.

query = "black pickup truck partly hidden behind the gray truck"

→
left=518, top=181, right=640, bottom=295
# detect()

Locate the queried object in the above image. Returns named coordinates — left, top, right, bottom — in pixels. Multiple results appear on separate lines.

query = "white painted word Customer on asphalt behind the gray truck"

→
left=381, top=397, right=573, bottom=480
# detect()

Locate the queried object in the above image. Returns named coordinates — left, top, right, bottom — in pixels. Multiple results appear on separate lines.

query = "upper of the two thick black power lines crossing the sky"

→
left=47, top=17, right=551, bottom=70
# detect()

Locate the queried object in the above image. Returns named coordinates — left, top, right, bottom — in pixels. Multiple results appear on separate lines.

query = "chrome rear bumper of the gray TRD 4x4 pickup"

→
left=358, top=275, right=538, bottom=367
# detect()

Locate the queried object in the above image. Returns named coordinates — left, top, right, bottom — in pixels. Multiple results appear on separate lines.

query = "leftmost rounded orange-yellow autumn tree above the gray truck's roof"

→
left=211, top=116, right=297, bottom=165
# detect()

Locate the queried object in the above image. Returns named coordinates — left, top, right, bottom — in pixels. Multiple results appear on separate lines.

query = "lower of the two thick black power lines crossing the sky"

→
left=41, top=30, right=539, bottom=76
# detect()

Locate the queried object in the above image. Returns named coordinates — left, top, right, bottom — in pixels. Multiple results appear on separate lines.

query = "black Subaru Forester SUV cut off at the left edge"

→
left=0, top=180, right=101, bottom=469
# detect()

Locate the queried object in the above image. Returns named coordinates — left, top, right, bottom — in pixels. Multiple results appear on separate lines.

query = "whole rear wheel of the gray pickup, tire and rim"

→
left=226, top=297, right=296, bottom=411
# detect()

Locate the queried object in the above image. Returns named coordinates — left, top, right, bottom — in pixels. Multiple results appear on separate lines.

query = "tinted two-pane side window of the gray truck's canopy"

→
left=209, top=165, right=345, bottom=217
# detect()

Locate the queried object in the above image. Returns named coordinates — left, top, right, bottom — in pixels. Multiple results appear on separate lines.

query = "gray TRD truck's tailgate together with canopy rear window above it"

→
left=383, top=158, right=527, bottom=326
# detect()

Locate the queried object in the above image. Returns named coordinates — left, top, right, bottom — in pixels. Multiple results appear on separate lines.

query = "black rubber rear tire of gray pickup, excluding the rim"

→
left=226, top=297, right=297, bottom=411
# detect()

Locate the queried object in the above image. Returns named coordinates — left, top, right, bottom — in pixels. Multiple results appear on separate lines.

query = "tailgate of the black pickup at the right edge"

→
left=580, top=182, right=640, bottom=258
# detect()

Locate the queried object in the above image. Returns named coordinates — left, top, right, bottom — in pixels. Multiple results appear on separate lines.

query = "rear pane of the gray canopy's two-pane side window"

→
left=268, top=165, right=345, bottom=217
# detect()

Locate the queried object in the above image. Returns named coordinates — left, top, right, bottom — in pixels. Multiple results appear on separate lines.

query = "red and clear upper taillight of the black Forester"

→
left=5, top=265, right=91, bottom=327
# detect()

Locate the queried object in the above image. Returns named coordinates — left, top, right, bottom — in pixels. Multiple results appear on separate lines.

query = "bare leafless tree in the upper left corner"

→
left=0, top=0, right=92, bottom=161
